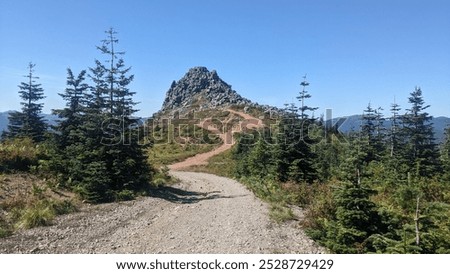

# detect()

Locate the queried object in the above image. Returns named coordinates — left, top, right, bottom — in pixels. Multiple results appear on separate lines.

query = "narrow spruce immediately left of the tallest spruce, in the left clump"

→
left=71, top=61, right=111, bottom=203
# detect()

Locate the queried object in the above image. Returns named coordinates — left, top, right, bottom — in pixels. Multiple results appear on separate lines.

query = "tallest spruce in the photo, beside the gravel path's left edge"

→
left=88, top=29, right=150, bottom=198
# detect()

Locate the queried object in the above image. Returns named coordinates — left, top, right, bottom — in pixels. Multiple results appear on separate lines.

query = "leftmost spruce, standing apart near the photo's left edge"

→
left=5, top=62, right=47, bottom=142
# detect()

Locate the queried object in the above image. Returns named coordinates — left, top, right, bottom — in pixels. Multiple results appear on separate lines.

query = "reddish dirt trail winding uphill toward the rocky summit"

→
left=168, top=109, right=263, bottom=170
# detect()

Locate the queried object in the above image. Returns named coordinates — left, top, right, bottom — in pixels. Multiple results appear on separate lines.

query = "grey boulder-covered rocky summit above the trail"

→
left=161, top=67, right=252, bottom=112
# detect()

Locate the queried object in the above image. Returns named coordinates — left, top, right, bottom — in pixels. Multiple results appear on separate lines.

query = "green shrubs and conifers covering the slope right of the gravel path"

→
left=195, top=84, right=450, bottom=253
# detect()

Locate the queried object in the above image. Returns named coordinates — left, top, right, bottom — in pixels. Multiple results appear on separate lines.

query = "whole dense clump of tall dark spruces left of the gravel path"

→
left=49, top=29, right=151, bottom=202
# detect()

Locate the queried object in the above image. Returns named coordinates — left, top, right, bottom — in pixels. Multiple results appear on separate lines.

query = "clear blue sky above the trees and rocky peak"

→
left=0, top=0, right=450, bottom=116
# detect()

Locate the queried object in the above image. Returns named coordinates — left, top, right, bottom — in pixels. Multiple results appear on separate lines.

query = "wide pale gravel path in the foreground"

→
left=0, top=171, right=324, bottom=253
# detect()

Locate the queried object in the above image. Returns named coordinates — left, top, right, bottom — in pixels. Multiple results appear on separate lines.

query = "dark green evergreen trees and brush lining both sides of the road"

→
left=0, top=29, right=450, bottom=254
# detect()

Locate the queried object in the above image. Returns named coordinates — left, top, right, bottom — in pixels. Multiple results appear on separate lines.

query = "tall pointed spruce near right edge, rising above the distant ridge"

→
left=402, top=87, right=440, bottom=177
